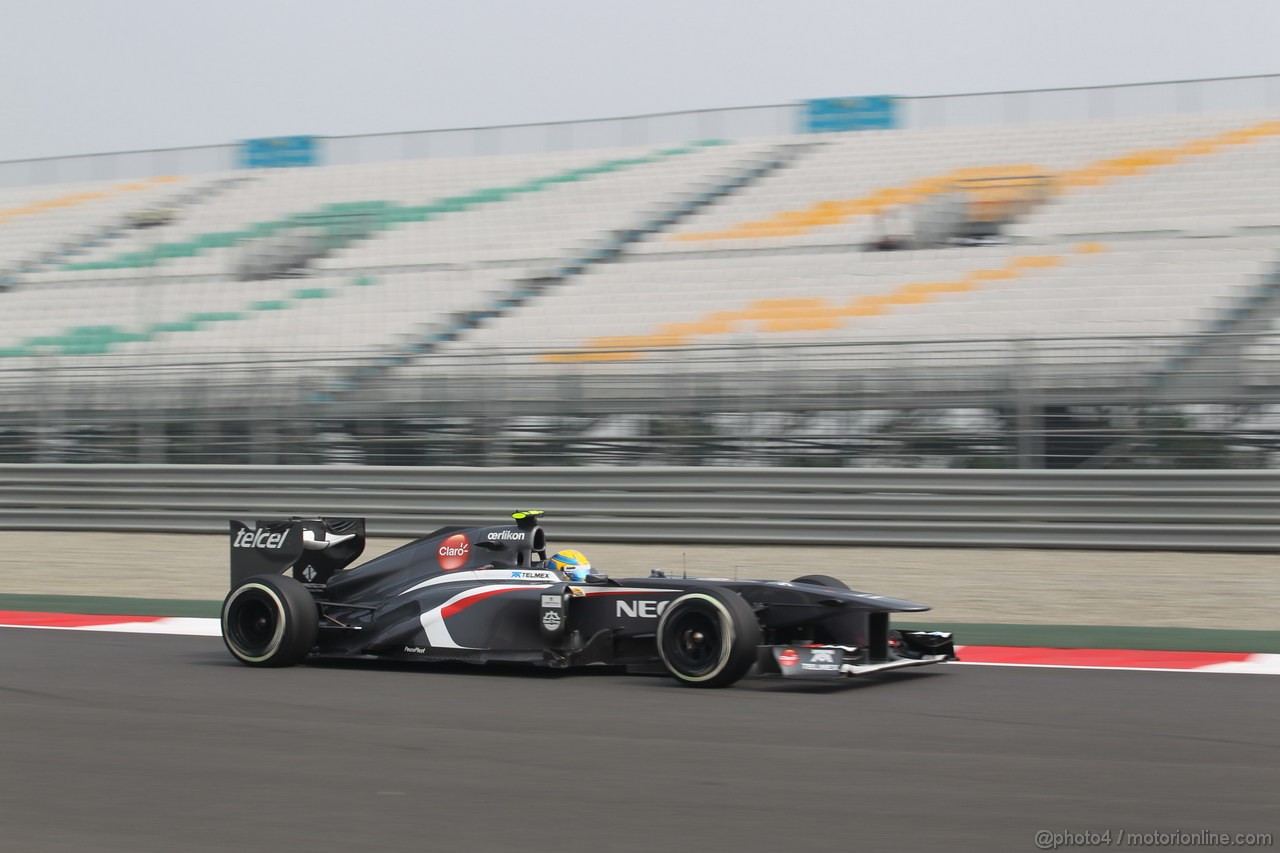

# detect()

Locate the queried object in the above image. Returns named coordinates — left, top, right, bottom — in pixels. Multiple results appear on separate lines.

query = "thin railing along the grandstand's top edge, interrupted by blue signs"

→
left=0, top=74, right=1280, bottom=187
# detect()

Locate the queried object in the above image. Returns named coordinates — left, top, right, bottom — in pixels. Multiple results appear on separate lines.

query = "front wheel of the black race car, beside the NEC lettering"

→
left=658, top=587, right=762, bottom=688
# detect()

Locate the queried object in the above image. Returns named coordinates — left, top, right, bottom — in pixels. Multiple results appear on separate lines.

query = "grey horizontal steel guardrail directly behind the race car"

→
left=0, top=465, right=1280, bottom=552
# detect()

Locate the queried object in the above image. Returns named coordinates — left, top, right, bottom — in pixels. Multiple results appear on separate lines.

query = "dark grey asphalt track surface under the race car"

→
left=0, top=629, right=1280, bottom=853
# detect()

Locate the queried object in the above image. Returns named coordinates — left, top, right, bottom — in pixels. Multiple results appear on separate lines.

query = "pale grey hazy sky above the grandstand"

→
left=0, top=0, right=1280, bottom=160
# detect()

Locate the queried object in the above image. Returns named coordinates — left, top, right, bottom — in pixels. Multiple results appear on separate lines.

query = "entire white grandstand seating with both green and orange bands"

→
left=0, top=97, right=1280, bottom=464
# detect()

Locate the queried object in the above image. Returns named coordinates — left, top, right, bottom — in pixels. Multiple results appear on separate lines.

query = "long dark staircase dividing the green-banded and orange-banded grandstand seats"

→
left=317, top=141, right=826, bottom=402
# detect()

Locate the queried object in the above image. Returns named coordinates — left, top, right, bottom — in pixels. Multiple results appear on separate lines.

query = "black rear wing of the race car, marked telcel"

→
left=230, top=517, right=365, bottom=588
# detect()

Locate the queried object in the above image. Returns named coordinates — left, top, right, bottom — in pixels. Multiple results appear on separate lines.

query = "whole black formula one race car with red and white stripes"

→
left=221, top=511, right=956, bottom=686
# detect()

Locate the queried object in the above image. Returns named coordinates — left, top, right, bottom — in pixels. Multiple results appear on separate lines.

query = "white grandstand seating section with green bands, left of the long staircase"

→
left=0, top=145, right=788, bottom=360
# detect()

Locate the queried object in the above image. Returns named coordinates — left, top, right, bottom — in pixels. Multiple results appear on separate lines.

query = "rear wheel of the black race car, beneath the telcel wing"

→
left=221, top=575, right=320, bottom=666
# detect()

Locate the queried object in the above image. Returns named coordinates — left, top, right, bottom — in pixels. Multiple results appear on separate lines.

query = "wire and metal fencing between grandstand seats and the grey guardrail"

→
left=0, top=333, right=1280, bottom=469
